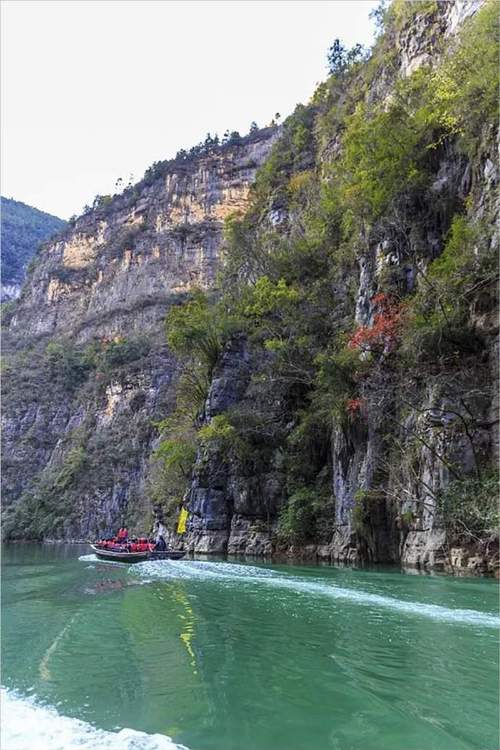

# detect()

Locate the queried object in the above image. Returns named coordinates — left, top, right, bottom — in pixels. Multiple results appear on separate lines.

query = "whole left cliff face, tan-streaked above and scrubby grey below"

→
left=2, top=128, right=278, bottom=538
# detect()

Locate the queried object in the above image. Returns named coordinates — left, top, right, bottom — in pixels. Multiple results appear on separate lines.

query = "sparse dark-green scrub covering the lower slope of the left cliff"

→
left=2, top=336, right=156, bottom=539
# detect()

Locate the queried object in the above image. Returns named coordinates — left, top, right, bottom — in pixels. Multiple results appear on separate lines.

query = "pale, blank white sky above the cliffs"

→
left=1, top=0, right=378, bottom=219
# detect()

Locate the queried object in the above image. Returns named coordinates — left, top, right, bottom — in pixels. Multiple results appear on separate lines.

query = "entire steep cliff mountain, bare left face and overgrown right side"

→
left=2, top=0, right=499, bottom=572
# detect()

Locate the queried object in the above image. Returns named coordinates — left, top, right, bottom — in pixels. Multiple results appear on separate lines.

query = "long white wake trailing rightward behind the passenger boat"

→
left=134, top=560, right=500, bottom=628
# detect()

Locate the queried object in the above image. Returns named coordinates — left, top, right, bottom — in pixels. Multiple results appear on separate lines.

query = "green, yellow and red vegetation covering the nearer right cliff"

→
left=155, top=2, right=498, bottom=544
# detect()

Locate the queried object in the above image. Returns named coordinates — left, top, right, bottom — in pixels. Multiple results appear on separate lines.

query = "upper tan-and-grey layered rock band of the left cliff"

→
left=10, top=128, right=277, bottom=342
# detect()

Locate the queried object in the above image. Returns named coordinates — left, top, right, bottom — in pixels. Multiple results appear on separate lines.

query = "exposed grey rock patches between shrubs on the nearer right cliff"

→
left=175, top=0, right=499, bottom=572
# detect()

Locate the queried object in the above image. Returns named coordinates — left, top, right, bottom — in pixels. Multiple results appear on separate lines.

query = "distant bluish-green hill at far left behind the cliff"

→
left=1, top=196, right=66, bottom=300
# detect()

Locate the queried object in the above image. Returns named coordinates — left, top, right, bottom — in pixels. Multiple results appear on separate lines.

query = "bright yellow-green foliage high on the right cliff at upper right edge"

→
left=337, top=2, right=500, bottom=232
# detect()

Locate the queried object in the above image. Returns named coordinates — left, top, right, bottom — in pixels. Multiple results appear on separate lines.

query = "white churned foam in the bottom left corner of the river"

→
left=0, top=688, right=186, bottom=750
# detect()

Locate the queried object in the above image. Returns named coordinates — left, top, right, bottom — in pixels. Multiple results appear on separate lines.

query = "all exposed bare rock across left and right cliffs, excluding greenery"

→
left=3, top=0, right=499, bottom=572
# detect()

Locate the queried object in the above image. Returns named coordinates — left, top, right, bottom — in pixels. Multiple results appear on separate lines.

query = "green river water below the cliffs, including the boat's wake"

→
left=2, top=545, right=499, bottom=750
